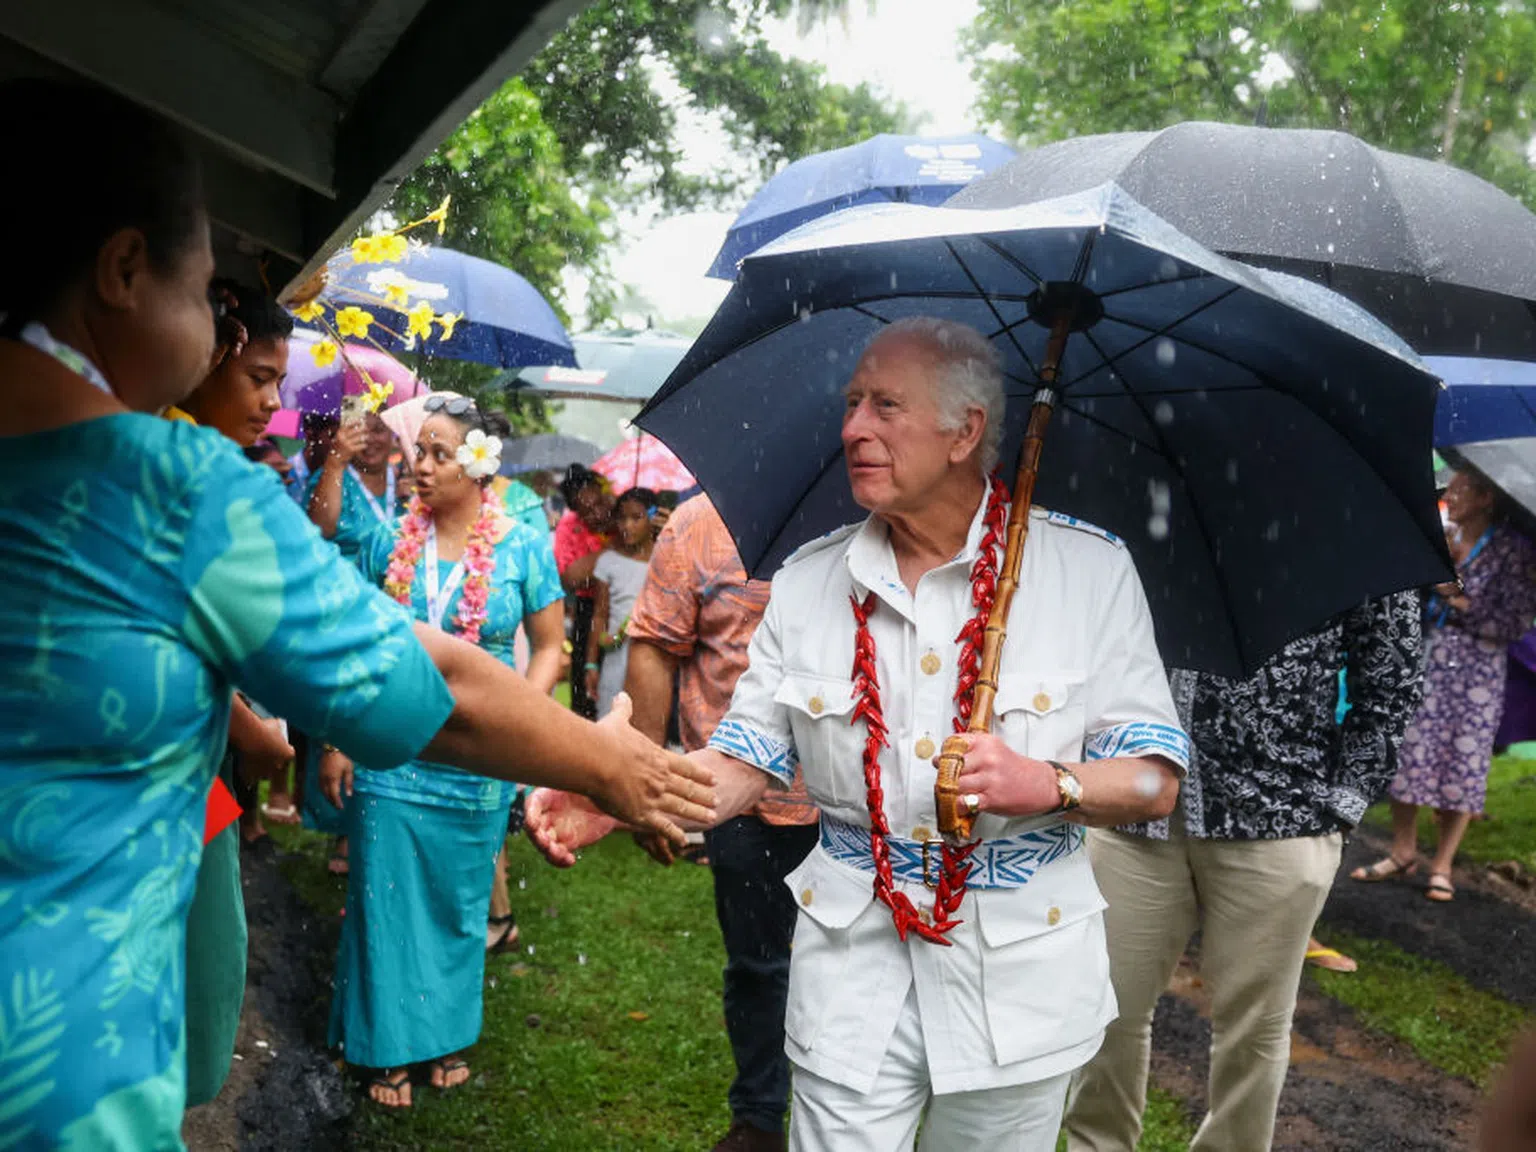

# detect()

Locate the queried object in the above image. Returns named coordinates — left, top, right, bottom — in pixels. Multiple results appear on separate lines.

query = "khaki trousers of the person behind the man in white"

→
left=1066, top=817, right=1342, bottom=1152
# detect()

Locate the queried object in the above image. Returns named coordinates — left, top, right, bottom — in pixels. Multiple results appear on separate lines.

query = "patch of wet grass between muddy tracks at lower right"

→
left=1309, top=925, right=1533, bottom=1086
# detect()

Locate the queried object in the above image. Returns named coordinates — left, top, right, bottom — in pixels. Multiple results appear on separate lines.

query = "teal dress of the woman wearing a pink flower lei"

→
left=330, top=509, right=565, bottom=1068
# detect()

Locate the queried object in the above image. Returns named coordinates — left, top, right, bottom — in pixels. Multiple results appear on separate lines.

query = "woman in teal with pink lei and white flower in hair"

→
left=321, top=396, right=565, bottom=1107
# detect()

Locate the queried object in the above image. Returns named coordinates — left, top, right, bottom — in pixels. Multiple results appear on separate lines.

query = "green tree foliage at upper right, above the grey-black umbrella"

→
left=968, top=0, right=1536, bottom=206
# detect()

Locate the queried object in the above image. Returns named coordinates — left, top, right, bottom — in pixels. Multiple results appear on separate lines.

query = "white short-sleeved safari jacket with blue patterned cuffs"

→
left=710, top=504, right=1189, bottom=1094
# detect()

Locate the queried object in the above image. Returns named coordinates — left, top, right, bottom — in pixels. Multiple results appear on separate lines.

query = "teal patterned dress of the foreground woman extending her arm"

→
left=0, top=415, right=453, bottom=1150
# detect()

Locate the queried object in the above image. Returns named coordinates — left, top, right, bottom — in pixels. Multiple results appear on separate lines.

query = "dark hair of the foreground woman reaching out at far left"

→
left=0, top=78, right=207, bottom=332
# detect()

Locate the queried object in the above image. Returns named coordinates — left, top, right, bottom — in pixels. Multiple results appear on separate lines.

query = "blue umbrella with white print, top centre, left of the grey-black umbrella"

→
left=708, top=134, right=1014, bottom=280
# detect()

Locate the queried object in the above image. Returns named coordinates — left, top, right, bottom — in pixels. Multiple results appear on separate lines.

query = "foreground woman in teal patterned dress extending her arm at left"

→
left=0, top=80, right=710, bottom=1152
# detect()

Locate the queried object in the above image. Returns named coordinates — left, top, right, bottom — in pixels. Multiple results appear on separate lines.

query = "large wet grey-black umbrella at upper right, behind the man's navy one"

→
left=949, top=121, right=1536, bottom=359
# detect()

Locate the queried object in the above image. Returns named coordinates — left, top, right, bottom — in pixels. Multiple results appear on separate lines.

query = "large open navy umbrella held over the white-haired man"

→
left=637, top=184, right=1450, bottom=676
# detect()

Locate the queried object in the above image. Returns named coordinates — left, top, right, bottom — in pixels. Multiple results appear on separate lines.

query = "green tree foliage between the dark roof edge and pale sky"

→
left=389, top=0, right=909, bottom=414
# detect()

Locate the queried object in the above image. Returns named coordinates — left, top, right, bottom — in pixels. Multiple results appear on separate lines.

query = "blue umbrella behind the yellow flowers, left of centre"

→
left=324, top=244, right=576, bottom=369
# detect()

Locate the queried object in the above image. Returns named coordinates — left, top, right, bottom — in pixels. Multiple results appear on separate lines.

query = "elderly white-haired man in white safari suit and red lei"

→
left=530, top=318, right=1187, bottom=1152
